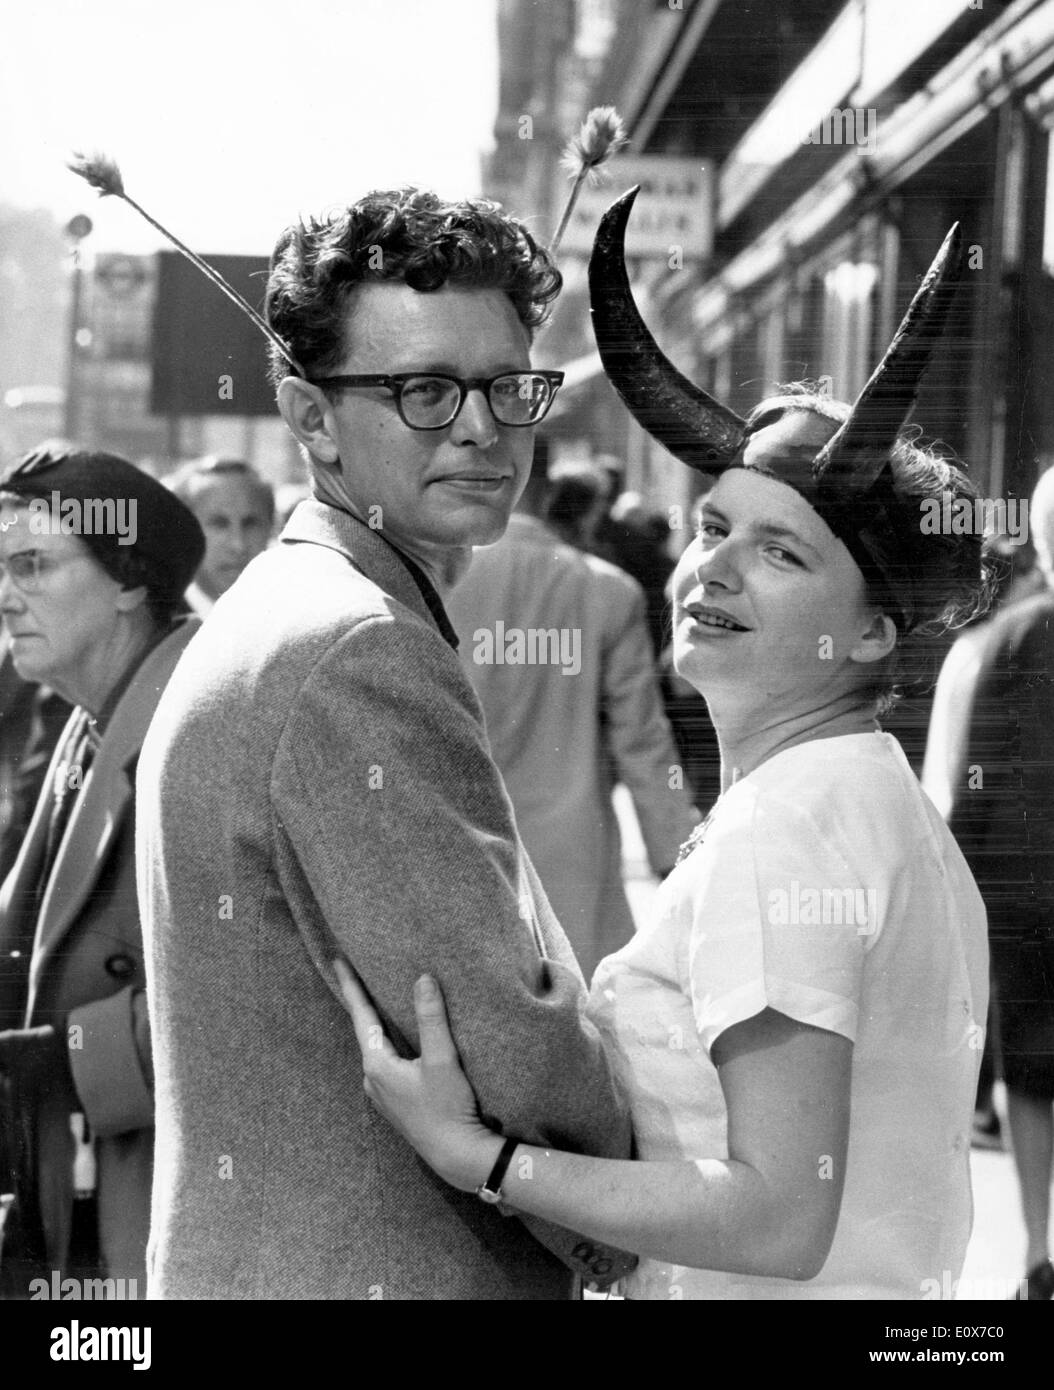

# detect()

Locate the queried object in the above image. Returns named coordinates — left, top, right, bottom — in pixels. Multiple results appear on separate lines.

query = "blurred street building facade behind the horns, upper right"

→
left=487, top=0, right=1054, bottom=536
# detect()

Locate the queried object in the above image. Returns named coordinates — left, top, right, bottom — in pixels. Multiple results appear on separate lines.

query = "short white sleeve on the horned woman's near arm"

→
left=684, top=784, right=889, bottom=1051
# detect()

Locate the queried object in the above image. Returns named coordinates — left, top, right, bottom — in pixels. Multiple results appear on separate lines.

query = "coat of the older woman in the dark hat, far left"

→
left=0, top=619, right=200, bottom=1291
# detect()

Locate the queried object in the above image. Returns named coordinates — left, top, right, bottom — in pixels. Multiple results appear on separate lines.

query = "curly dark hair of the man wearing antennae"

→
left=264, top=188, right=563, bottom=385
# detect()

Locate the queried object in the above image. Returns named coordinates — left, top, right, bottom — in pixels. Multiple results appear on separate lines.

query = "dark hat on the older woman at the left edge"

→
left=0, top=445, right=204, bottom=605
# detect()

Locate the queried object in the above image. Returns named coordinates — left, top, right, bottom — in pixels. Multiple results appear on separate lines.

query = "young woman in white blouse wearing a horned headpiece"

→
left=337, top=204, right=987, bottom=1298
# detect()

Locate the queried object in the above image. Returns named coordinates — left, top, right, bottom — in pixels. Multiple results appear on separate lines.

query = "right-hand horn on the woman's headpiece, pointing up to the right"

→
left=812, top=222, right=962, bottom=492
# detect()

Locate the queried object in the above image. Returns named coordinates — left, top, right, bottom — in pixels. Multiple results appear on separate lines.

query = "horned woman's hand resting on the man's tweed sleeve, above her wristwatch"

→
left=334, top=956, right=502, bottom=1193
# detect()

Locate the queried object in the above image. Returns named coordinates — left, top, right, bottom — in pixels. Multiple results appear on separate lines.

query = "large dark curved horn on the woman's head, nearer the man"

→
left=590, top=186, right=747, bottom=473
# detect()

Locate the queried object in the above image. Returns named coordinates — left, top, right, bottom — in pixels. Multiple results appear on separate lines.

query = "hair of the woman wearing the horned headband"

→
left=747, top=382, right=1001, bottom=713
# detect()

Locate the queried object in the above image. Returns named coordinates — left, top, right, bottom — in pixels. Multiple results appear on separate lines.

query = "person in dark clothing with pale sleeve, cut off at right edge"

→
left=927, top=470, right=1054, bottom=1301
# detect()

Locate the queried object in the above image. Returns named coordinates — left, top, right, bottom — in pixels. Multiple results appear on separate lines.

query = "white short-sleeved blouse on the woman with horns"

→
left=590, top=734, right=989, bottom=1298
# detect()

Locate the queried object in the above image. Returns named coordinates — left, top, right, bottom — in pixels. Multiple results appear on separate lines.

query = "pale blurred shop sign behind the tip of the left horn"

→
left=553, top=154, right=713, bottom=264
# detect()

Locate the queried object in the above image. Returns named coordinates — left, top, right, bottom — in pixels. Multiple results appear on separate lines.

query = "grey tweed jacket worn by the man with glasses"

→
left=136, top=500, right=629, bottom=1300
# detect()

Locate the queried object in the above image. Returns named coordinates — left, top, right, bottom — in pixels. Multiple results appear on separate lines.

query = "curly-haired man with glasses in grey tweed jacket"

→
left=138, top=190, right=629, bottom=1300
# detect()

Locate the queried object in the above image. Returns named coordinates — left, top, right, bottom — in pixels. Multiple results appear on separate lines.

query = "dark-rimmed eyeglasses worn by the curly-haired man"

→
left=309, top=371, right=563, bottom=430
